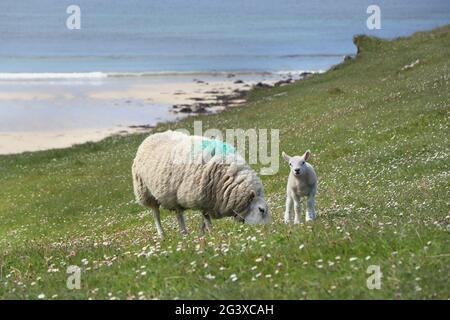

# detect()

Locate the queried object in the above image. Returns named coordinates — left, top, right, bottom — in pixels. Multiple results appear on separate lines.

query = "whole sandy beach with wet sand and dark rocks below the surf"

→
left=0, top=76, right=291, bottom=154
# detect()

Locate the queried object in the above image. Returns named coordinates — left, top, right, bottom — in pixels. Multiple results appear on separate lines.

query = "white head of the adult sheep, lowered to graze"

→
left=235, top=190, right=271, bottom=224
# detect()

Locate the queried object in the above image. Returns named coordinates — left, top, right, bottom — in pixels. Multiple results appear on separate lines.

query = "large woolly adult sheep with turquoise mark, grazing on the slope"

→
left=132, top=130, right=270, bottom=237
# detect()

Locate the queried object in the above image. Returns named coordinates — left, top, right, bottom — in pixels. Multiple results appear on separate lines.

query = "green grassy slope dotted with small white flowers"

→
left=0, top=26, right=450, bottom=299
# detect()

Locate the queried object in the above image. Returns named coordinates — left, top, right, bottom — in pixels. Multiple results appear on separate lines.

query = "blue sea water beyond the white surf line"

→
left=0, top=0, right=450, bottom=74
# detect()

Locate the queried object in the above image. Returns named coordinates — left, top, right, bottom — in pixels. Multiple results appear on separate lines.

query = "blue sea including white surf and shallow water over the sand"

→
left=0, top=0, right=450, bottom=135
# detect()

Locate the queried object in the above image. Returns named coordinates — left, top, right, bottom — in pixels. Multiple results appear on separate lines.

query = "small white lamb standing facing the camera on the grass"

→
left=282, top=150, right=317, bottom=224
